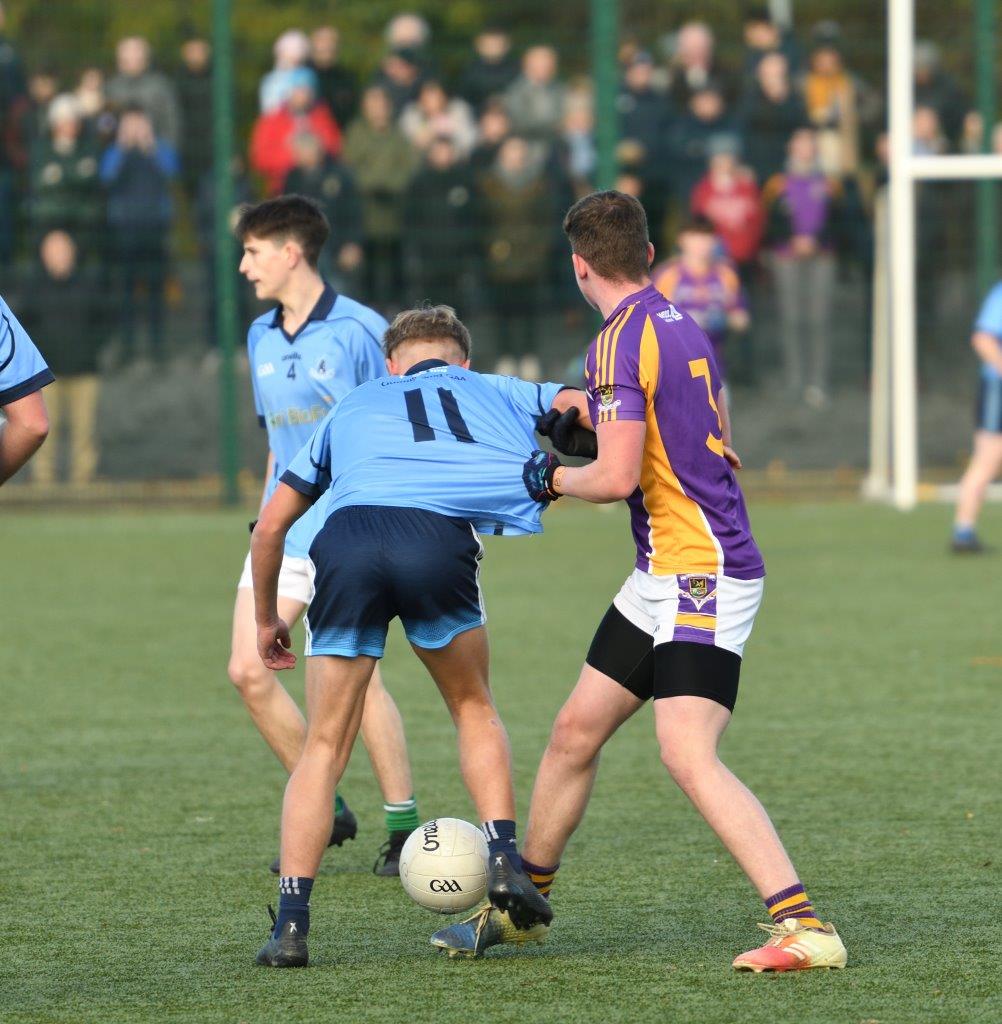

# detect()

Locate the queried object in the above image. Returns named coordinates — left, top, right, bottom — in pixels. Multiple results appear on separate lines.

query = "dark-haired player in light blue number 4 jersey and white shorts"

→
left=229, top=196, right=419, bottom=876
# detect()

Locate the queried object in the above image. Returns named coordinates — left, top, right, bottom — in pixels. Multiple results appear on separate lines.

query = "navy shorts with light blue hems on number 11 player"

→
left=306, top=505, right=487, bottom=657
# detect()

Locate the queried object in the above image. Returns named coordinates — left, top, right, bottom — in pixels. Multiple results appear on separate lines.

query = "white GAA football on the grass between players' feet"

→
left=400, top=818, right=487, bottom=913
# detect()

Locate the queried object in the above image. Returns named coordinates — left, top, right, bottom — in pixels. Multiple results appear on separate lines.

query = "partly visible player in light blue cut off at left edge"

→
left=0, top=298, right=55, bottom=484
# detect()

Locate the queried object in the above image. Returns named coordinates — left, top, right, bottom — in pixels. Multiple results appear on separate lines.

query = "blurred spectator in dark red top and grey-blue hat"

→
left=691, top=135, right=766, bottom=279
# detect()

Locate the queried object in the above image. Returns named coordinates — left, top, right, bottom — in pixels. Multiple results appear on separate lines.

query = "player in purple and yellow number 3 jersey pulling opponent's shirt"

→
left=432, top=191, right=845, bottom=972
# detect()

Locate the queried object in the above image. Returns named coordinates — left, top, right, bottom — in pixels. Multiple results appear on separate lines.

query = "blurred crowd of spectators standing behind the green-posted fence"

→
left=0, top=7, right=1002, bottom=479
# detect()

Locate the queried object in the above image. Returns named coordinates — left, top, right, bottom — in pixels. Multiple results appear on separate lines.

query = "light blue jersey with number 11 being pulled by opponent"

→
left=281, top=359, right=563, bottom=542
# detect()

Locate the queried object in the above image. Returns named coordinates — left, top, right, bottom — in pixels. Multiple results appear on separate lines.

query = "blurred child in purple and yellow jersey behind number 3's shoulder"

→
left=651, top=217, right=749, bottom=380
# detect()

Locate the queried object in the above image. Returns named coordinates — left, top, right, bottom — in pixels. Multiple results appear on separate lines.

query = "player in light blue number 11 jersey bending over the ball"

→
left=251, top=306, right=591, bottom=967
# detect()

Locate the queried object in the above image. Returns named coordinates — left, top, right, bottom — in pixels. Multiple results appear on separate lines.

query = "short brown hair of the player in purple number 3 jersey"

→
left=564, top=189, right=651, bottom=282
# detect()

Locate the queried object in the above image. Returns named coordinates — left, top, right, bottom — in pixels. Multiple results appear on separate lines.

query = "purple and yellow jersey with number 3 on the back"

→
left=584, top=285, right=766, bottom=580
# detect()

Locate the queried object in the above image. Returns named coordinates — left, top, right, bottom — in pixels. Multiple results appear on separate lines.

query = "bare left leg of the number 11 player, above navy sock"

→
left=281, top=654, right=376, bottom=878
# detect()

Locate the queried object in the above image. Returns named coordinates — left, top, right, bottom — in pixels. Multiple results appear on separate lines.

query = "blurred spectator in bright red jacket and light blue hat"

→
left=251, top=68, right=341, bottom=196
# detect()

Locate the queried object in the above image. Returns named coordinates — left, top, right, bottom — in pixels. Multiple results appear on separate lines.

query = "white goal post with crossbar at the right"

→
left=864, top=0, right=1002, bottom=509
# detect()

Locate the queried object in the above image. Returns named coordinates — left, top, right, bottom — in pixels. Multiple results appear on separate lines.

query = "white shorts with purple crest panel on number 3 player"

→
left=612, top=569, right=766, bottom=657
